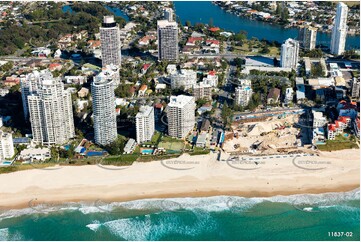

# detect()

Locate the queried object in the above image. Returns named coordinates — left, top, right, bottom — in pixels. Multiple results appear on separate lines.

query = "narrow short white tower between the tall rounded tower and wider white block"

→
left=135, top=106, right=155, bottom=144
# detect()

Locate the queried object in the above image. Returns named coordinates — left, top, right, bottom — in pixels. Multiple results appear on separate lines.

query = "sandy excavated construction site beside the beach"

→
left=223, top=114, right=309, bottom=155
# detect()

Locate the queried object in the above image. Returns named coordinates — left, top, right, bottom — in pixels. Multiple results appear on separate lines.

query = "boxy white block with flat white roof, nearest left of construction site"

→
left=167, top=95, right=196, bottom=138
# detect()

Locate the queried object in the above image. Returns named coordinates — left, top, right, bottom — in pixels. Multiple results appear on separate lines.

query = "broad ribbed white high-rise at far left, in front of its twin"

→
left=23, top=71, right=75, bottom=145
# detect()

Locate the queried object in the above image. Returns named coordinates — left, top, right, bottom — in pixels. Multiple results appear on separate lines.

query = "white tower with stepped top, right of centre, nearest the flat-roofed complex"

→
left=281, top=39, right=300, bottom=69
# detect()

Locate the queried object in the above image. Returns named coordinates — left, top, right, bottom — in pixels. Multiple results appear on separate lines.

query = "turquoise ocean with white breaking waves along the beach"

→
left=0, top=189, right=360, bottom=241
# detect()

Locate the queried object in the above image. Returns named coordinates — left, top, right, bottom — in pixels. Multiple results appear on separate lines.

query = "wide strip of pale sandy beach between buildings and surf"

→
left=0, top=149, right=360, bottom=208
